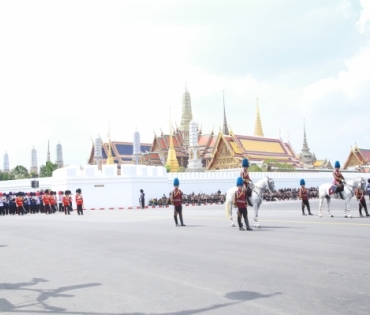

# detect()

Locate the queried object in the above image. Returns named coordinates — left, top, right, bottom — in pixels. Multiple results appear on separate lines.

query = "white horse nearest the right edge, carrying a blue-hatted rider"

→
left=319, top=177, right=365, bottom=218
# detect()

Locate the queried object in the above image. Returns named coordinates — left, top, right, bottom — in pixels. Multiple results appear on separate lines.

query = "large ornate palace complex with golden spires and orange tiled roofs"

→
left=88, top=86, right=331, bottom=171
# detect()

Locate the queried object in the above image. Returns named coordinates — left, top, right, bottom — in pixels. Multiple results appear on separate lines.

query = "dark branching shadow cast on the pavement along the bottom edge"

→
left=0, top=278, right=281, bottom=315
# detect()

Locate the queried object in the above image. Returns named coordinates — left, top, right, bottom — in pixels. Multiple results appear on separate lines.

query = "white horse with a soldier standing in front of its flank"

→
left=225, top=176, right=275, bottom=228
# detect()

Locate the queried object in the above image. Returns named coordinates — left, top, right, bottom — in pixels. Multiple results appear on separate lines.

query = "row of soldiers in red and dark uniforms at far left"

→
left=0, top=189, right=83, bottom=215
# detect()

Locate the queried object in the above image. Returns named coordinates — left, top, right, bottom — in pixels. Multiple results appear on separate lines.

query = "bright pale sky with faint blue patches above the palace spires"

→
left=0, top=0, right=370, bottom=169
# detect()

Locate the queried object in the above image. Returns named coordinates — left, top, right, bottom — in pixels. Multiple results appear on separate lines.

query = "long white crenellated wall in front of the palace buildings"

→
left=0, top=165, right=369, bottom=209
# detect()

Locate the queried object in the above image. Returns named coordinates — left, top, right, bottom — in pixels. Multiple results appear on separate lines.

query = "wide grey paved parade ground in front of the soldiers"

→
left=0, top=200, right=370, bottom=315
